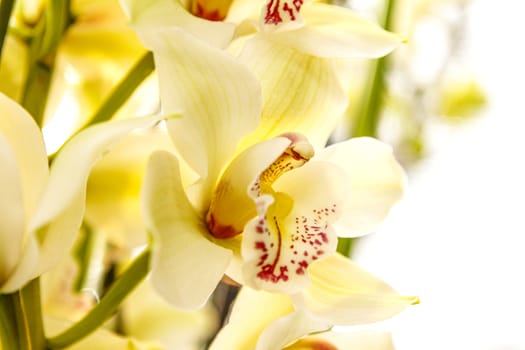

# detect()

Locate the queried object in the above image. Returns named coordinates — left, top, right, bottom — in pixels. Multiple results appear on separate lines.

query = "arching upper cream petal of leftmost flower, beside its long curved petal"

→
left=0, top=93, right=49, bottom=223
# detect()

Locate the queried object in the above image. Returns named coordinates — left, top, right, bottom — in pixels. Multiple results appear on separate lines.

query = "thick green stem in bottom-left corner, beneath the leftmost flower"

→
left=0, top=278, right=44, bottom=350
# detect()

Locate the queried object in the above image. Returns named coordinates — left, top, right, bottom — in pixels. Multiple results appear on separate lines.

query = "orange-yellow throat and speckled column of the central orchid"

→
left=206, top=133, right=314, bottom=238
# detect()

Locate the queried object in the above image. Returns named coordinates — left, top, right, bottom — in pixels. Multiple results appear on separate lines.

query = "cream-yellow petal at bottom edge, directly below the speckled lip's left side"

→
left=210, top=287, right=293, bottom=350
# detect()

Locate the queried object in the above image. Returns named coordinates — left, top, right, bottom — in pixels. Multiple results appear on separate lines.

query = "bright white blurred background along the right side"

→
left=346, top=0, right=525, bottom=350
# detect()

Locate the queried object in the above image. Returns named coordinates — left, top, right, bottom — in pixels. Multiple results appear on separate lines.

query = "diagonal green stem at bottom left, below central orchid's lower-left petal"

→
left=47, top=250, right=150, bottom=349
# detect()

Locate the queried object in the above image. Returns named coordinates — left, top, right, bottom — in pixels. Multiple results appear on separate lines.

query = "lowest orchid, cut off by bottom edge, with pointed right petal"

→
left=211, top=254, right=418, bottom=350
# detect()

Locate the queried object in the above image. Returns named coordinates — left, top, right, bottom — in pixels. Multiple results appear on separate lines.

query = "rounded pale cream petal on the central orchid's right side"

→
left=319, top=137, right=406, bottom=237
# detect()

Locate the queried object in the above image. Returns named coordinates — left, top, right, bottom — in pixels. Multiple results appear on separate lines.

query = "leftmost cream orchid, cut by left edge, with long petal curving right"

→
left=0, top=94, right=169, bottom=293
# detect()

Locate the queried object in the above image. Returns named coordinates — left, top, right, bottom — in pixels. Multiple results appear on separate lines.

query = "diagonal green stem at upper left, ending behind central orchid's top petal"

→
left=89, top=51, right=155, bottom=125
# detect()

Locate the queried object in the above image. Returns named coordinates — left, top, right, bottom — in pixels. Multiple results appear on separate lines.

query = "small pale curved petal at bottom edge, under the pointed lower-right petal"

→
left=256, top=310, right=330, bottom=350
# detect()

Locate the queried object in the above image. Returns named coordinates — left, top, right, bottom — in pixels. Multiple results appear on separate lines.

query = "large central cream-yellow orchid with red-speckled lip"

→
left=119, top=1, right=410, bottom=308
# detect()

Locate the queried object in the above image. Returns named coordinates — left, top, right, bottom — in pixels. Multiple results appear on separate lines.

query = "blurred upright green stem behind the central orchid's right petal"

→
left=337, top=0, right=395, bottom=256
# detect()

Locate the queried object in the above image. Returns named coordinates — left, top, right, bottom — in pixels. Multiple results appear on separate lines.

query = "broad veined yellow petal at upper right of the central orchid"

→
left=239, top=35, right=348, bottom=149
